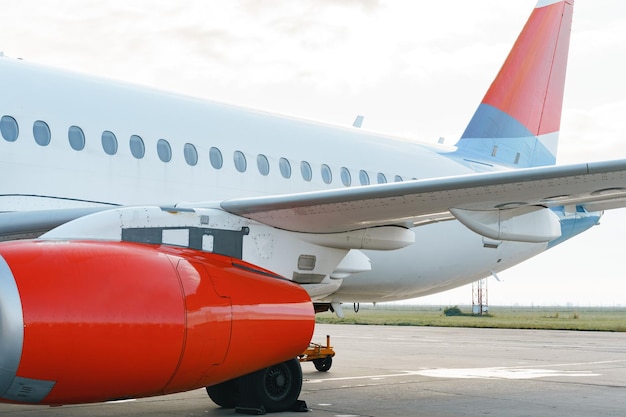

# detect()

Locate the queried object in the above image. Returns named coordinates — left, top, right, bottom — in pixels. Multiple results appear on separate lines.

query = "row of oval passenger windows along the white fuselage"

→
left=0, top=115, right=410, bottom=187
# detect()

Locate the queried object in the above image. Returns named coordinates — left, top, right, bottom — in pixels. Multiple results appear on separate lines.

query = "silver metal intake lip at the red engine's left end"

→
left=0, top=257, right=24, bottom=400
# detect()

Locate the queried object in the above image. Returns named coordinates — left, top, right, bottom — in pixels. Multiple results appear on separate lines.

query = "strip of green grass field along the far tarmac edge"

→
left=317, top=304, right=626, bottom=332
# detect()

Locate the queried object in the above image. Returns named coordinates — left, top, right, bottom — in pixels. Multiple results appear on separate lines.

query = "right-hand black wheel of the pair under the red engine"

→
left=240, top=358, right=302, bottom=413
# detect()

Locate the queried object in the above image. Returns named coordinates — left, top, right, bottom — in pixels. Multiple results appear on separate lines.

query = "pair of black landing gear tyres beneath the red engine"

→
left=206, top=358, right=306, bottom=415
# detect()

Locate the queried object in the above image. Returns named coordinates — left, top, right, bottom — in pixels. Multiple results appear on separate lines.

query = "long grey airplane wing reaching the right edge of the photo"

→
left=216, top=160, right=626, bottom=233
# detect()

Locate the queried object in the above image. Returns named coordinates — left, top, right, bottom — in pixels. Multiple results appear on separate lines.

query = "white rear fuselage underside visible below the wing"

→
left=333, top=221, right=547, bottom=302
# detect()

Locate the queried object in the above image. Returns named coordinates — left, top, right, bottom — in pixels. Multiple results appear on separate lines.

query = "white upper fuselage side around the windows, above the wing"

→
left=0, top=58, right=470, bottom=208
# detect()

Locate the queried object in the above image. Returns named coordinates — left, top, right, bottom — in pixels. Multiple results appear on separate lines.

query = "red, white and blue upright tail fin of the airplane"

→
left=457, top=0, right=574, bottom=168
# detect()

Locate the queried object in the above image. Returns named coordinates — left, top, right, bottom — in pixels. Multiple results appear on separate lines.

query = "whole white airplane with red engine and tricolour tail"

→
left=0, top=0, right=626, bottom=412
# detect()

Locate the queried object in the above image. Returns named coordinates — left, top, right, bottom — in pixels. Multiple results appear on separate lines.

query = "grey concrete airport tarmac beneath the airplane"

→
left=0, top=325, right=626, bottom=417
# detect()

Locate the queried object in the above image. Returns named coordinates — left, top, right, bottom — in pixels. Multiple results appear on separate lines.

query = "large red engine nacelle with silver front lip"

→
left=0, top=241, right=314, bottom=404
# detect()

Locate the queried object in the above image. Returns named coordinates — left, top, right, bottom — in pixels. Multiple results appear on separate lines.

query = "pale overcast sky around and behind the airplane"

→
left=0, top=0, right=626, bottom=306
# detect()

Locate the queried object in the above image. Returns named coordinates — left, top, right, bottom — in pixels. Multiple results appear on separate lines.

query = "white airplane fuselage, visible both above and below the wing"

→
left=0, top=58, right=548, bottom=302
